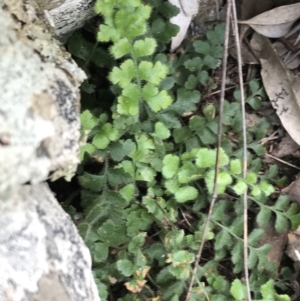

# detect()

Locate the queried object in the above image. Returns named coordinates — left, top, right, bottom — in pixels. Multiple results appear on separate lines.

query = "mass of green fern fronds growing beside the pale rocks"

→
left=69, top=0, right=300, bottom=301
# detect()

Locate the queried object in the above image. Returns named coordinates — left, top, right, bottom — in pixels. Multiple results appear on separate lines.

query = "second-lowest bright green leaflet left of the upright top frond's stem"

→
left=109, top=59, right=136, bottom=88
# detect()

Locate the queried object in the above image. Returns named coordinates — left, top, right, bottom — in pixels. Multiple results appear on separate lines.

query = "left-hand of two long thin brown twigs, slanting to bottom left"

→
left=185, top=1, right=231, bottom=301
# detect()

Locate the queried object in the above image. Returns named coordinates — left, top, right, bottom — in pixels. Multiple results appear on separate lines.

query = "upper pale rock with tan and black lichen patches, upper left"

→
left=0, top=0, right=85, bottom=199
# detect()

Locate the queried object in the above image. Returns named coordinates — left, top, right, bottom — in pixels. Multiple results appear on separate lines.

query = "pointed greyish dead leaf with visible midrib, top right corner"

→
left=239, top=3, right=300, bottom=38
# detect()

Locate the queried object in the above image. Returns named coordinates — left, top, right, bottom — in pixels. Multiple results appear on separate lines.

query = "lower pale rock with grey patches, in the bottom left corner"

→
left=0, top=183, right=100, bottom=301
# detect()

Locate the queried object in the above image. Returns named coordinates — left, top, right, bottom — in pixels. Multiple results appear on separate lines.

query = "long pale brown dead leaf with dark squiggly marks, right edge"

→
left=260, top=36, right=300, bottom=145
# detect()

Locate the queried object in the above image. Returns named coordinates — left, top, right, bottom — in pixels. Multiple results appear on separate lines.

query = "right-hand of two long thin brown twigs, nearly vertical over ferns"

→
left=229, top=0, right=251, bottom=301
